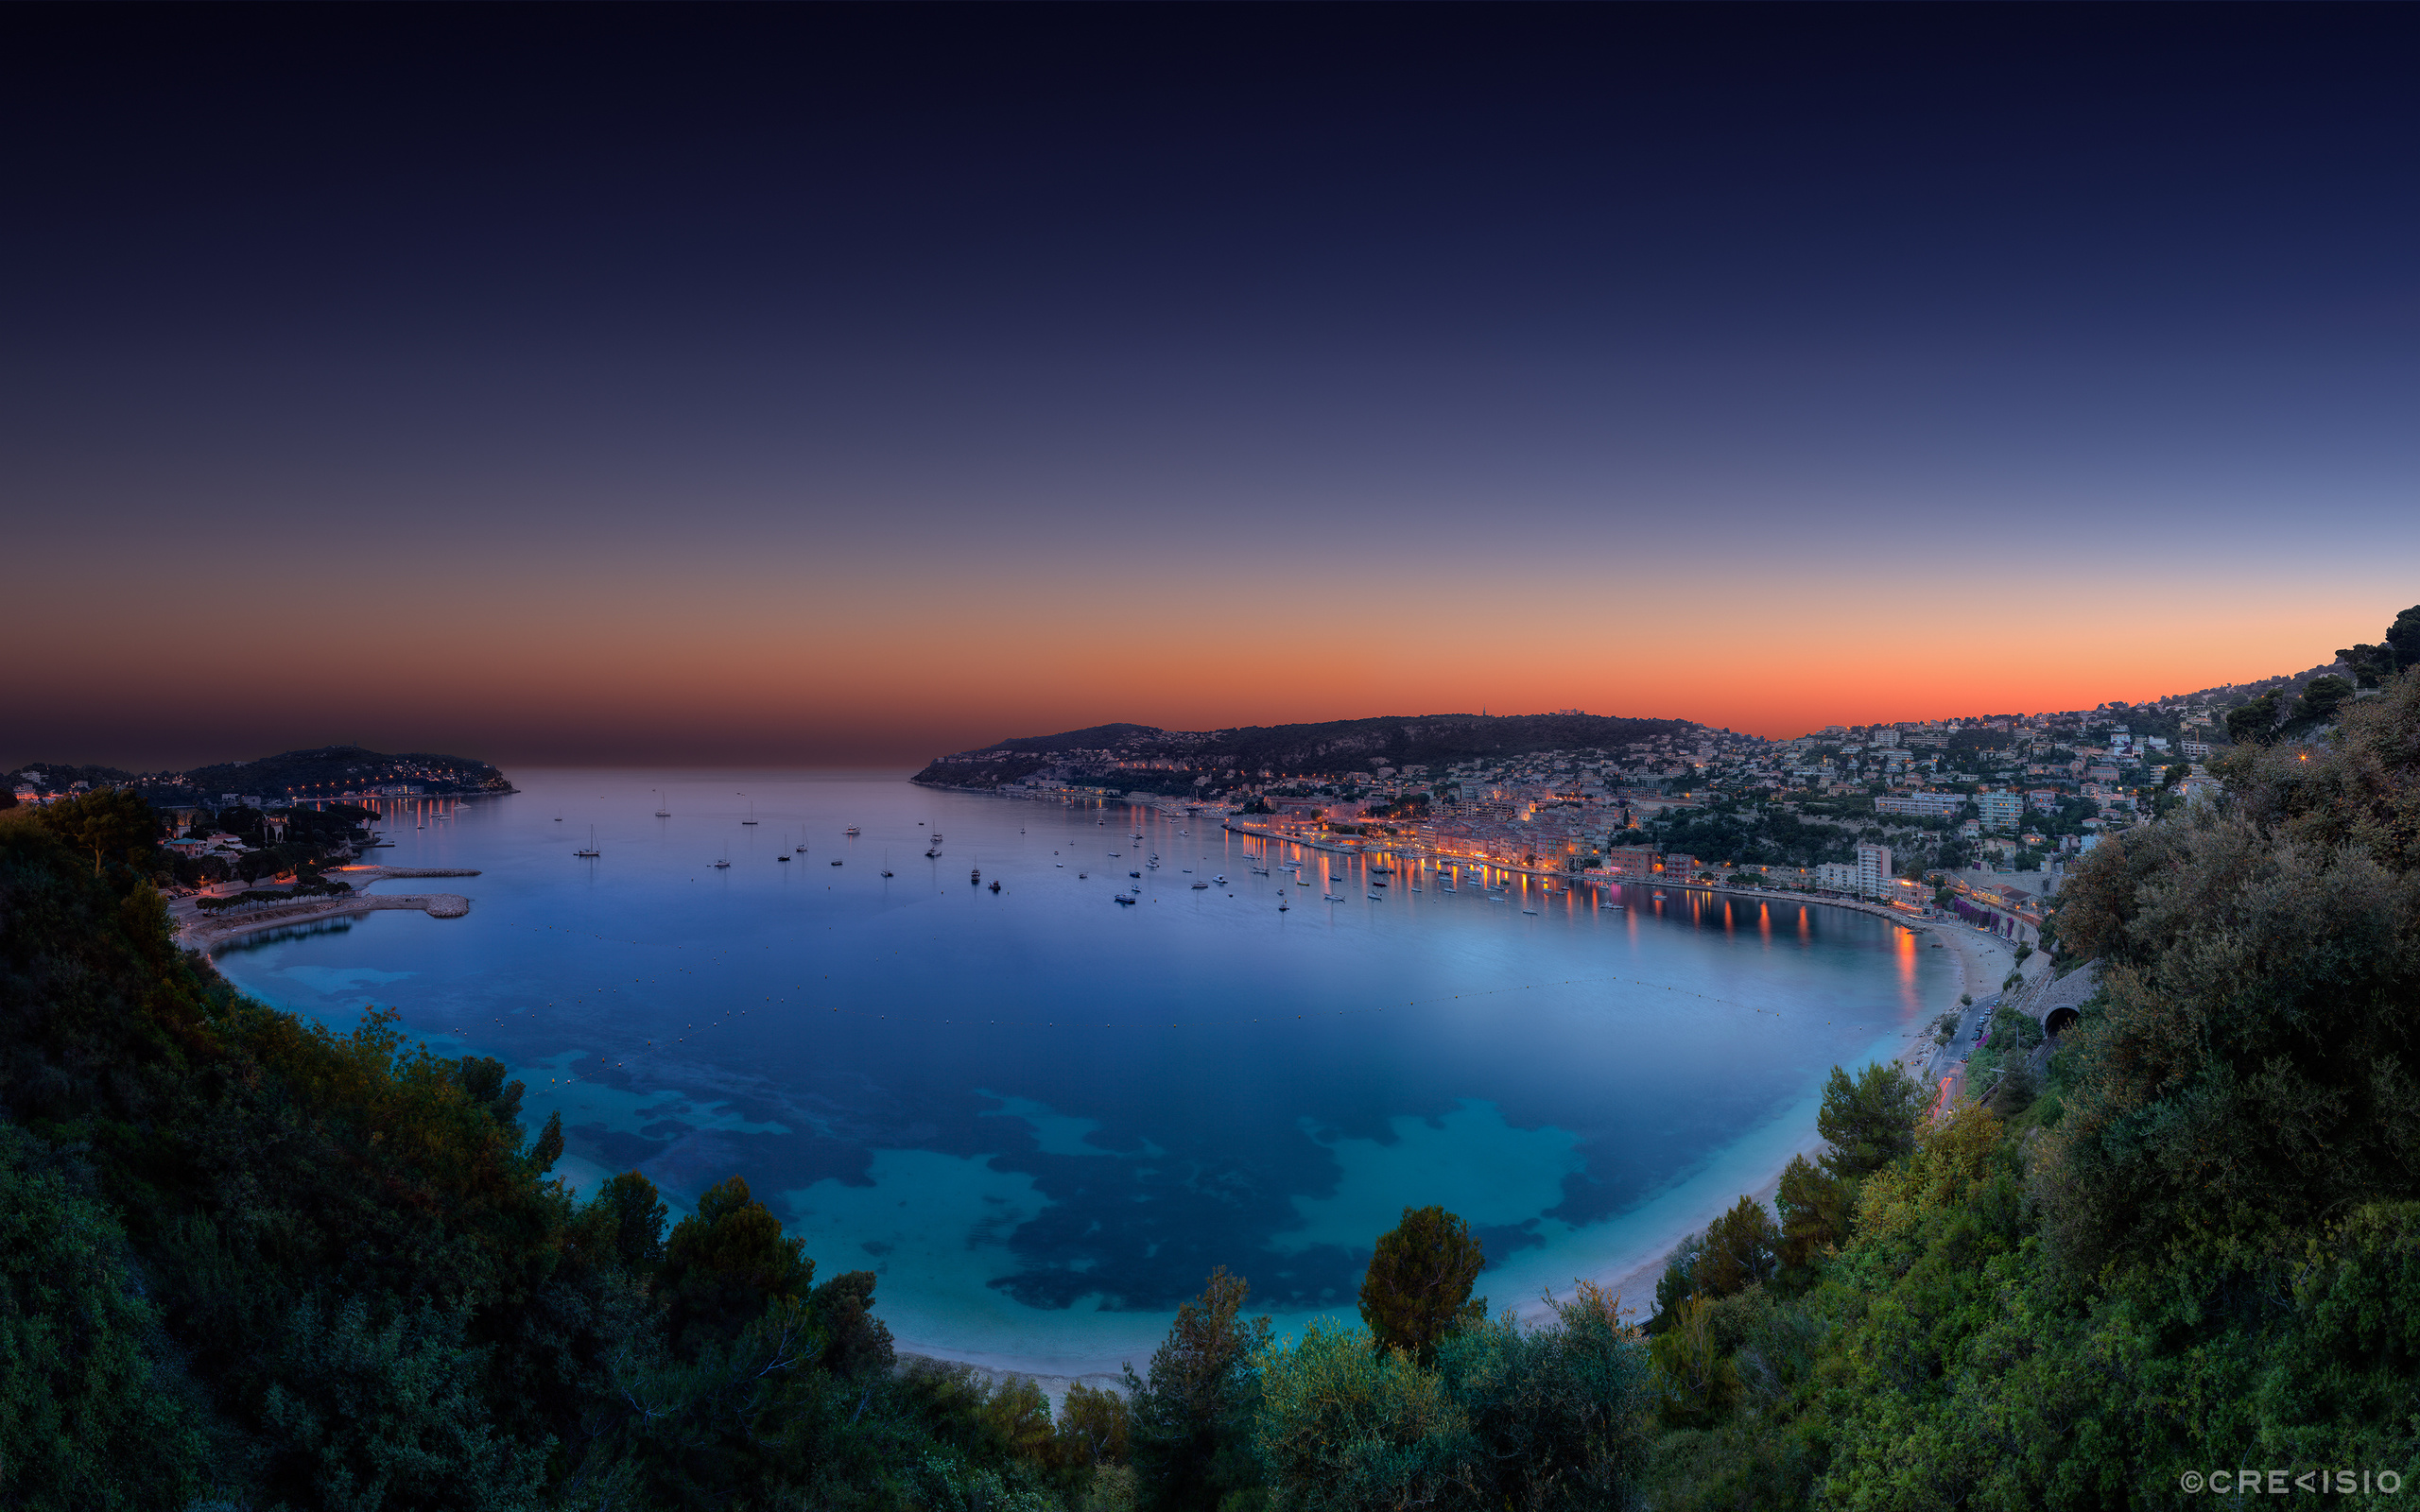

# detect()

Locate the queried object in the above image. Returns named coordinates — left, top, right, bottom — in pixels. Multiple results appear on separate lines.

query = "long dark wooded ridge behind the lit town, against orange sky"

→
left=915, top=713, right=1703, bottom=789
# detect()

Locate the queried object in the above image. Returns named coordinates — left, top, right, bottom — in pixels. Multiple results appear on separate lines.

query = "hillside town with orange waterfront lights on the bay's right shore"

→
left=920, top=656, right=2374, bottom=941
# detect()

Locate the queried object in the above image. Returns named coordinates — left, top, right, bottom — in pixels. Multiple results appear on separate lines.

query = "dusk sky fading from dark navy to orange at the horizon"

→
left=0, top=5, right=2420, bottom=769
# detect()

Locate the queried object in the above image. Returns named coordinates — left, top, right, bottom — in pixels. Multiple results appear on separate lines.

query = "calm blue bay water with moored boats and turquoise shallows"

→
left=220, top=772, right=1948, bottom=1372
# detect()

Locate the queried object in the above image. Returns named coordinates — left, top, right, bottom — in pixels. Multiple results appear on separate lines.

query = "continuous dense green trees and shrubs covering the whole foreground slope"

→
left=23, top=673, right=2420, bottom=1512
